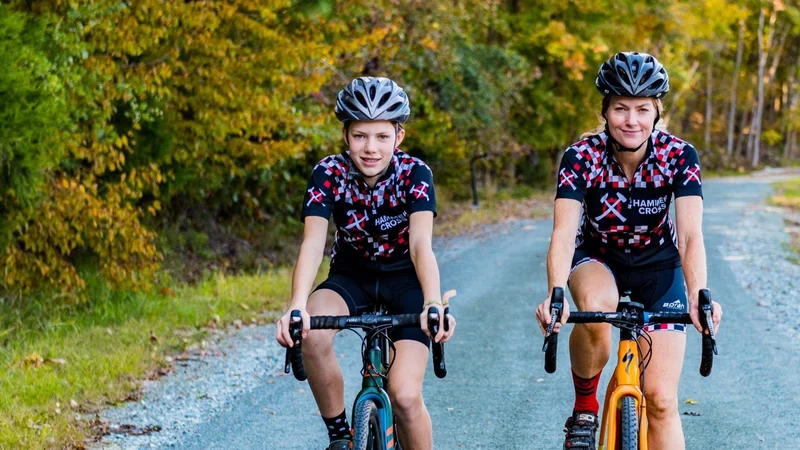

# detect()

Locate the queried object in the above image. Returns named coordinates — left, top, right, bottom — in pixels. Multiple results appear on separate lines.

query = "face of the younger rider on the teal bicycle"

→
left=342, top=120, right=405, bottom=186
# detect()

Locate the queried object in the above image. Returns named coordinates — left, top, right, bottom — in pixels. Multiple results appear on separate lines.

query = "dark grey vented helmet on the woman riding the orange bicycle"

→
left=595, top=52, right=669, bottom=98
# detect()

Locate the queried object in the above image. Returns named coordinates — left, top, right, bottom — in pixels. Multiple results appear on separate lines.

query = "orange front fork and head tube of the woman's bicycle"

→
left=597, top=329, right=647, bottom=450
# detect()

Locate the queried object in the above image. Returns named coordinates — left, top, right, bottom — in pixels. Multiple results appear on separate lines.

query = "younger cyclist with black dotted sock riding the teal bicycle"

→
left=276, top=77, right=455, bottom=450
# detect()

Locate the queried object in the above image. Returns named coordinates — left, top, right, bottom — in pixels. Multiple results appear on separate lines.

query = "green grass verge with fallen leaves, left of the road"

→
left=0, top=267, right=314, bottom=449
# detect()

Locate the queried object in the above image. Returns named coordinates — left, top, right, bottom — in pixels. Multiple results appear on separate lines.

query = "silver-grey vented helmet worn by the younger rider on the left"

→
left=335, top=77, right=411, bottom=123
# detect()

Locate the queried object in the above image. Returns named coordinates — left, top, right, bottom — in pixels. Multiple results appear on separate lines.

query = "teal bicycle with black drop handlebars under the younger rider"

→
left=284, top=307, right=450, bottom=450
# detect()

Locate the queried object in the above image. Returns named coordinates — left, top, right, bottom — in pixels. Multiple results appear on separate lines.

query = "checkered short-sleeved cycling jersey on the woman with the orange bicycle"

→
left=556, top=130, right=703, bottom=267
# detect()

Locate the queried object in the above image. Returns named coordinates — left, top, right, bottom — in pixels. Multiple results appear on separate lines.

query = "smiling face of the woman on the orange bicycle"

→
left=605, top=96, right=658, bottom=148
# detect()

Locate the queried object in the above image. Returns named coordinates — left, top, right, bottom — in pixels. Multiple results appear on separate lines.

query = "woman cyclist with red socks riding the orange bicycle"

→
left=536, top=52, right=722, bottom=450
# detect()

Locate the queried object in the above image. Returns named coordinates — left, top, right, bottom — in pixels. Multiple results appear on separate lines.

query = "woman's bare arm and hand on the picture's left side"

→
left=536, top=198, right=582, bottom=333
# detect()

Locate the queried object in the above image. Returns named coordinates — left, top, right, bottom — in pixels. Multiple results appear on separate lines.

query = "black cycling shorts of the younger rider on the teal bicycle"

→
left=314, top=269, right=430, bottom=346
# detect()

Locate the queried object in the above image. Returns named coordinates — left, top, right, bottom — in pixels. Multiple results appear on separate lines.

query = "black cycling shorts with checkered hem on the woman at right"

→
left=570, top=249, right=689, bottom=333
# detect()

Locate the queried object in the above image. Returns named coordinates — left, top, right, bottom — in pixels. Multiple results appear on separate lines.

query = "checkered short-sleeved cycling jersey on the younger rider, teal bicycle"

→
left=301, top=149, right=436, bottom=272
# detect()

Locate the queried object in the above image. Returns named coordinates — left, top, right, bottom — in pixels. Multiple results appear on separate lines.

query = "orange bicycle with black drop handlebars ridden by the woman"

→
left=542, top=287, right=719, bottom=450
